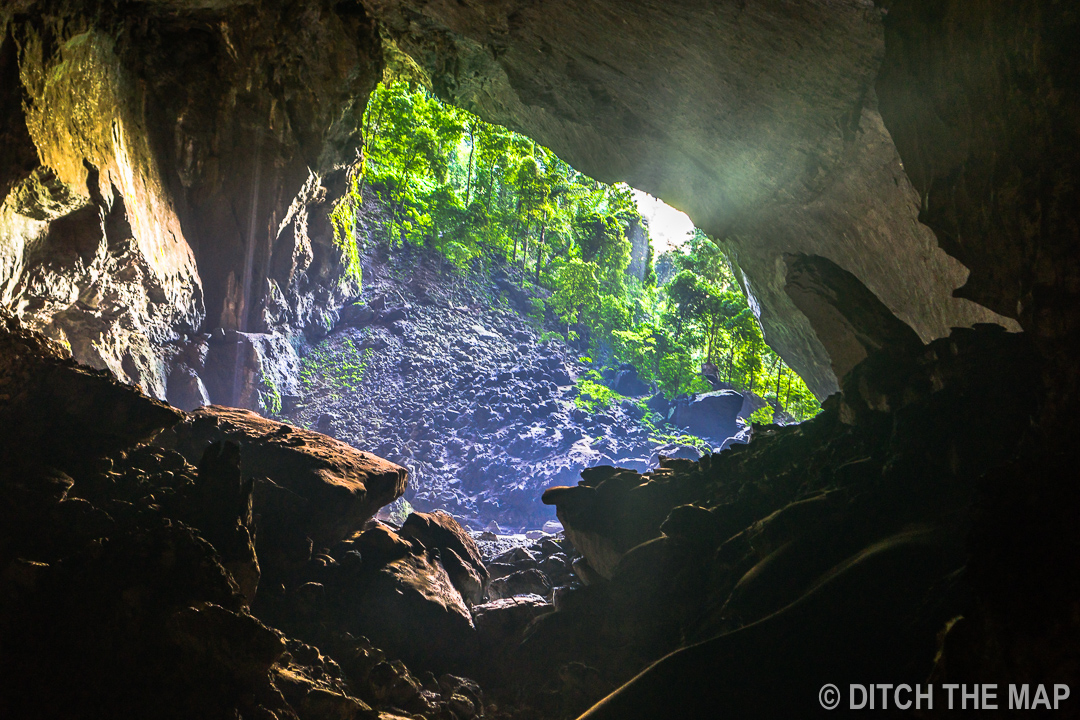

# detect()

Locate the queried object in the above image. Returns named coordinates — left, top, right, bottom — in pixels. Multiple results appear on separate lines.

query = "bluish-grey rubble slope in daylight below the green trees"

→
left=285, top=245, right=723, bottom=531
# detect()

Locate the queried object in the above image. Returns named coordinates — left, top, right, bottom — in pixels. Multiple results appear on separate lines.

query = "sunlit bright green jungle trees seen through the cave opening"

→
left=334, top=81, right=820, bottom=420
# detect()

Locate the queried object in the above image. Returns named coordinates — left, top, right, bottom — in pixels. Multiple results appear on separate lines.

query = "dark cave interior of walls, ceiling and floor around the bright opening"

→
left=0, top=0, right=1080, bottom=720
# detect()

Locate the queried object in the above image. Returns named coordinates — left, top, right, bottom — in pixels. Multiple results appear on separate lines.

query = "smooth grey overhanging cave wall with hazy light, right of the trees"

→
left=365, top=0, right=1017, bottom=396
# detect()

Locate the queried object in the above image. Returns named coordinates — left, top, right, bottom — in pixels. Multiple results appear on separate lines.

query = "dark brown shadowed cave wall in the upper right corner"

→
left=876, top=0, right=1080, bottom=360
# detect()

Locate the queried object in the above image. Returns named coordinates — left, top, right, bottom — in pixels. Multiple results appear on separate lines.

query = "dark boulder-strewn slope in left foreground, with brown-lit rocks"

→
left=0, top=321, right=591, bottom=720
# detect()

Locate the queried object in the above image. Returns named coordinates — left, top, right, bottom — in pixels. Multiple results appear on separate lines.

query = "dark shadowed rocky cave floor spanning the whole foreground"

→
left=0, top=310, right=1080, bottom=720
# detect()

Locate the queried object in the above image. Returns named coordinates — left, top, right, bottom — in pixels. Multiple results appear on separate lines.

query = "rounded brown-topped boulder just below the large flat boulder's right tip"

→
left=399, top=511, right=488, bottom=604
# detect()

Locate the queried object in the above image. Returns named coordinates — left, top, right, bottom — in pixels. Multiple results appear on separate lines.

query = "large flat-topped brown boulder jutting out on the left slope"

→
left=160, top=406, right=407, bottom=570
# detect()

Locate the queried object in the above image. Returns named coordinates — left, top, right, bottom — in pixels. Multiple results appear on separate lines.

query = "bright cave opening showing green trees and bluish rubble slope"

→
left=270, top=81, right=820, bottom=534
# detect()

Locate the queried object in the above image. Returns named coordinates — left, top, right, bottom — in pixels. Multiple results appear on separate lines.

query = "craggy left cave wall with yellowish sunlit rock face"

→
left=0, top=0, right=381, bottom=402
